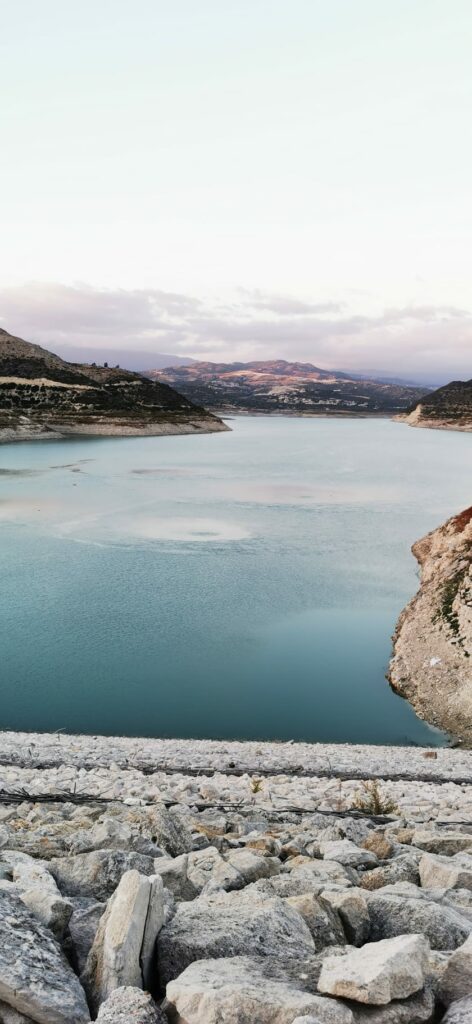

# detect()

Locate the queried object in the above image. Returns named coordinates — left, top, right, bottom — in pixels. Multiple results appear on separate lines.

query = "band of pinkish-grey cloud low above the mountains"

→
left=0, top=283, right=472, bottom=380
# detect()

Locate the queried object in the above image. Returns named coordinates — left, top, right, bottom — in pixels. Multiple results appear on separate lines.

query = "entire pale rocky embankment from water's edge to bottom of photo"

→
left=0, top=733, right=472, bottom=1024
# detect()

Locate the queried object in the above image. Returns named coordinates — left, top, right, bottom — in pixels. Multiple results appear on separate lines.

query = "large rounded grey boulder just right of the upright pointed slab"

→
left=158, top=887, right=314, bottom=987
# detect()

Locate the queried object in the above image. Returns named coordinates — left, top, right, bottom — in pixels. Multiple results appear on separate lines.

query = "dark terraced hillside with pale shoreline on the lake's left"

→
left=0, top=329, right=227, bottom=440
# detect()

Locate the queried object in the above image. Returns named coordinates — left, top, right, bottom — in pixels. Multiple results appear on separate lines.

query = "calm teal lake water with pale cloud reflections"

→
left=0, top=417, right=466, bottom=744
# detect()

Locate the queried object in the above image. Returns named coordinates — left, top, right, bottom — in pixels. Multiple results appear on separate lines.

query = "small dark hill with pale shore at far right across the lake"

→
left=398, top=380, right=472, bottom=430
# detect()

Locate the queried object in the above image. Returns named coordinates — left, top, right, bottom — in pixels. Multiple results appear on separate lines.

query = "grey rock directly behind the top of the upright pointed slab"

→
left=49, top=850, right=154, bottom=900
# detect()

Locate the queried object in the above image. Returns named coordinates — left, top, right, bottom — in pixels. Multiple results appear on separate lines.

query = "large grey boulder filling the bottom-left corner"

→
left=0, top=892, right=90, bottom=1024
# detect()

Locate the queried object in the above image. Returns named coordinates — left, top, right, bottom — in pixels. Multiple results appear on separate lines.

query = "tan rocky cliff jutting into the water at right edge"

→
left=389, top=508, right=472, bottom=745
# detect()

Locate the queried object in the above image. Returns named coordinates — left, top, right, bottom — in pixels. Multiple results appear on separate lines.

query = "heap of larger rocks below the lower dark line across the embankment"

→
left=0, top=782, right=472, bottom=1024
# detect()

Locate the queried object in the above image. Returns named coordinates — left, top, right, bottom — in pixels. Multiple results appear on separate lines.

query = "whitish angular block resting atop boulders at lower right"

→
left=318, top=935, right=429, bottom=1006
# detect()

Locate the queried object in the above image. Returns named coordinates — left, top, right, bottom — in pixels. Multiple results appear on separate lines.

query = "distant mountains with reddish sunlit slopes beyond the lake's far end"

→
left=146, top=359, right=429, bottom=416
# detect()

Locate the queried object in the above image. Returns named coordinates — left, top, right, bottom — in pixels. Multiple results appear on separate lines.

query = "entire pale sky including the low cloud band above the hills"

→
left=0, top=0, right=472, bottom=382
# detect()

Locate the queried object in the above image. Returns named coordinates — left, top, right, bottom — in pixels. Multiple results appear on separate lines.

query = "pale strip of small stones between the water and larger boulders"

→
left=0, top=731, right=472, bottom=825
